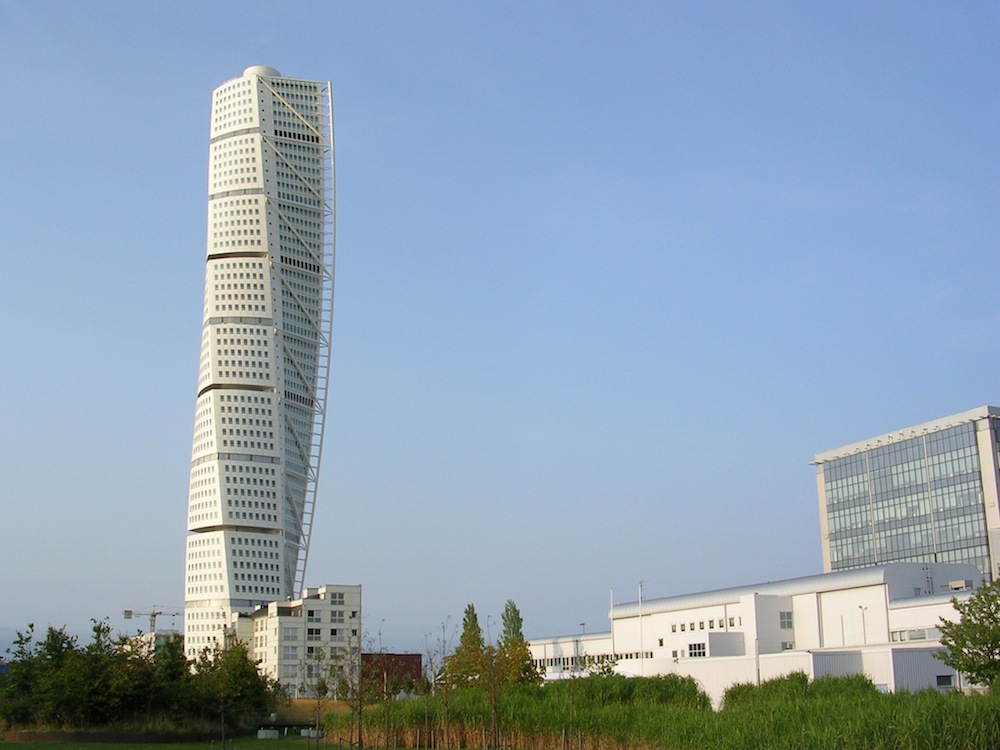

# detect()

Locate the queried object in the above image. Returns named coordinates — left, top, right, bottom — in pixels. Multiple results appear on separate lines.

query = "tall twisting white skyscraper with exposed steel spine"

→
left=184, top=66, right=334, bottom=655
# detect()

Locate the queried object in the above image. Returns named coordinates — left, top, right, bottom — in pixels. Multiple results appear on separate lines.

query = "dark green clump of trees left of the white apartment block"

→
left=0, top=621, right=278, bottom=730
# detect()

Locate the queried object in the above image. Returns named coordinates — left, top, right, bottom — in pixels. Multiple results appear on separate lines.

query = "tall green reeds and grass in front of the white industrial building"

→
left=326, top=673, right=1000, bottom=750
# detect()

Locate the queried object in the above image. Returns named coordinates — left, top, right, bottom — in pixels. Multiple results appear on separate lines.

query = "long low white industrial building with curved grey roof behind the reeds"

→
left=529, top=563, right=982, bottom=705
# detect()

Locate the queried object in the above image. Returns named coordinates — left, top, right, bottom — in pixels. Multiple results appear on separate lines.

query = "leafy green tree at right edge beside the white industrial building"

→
left=936, top=581, right=1000, bottom=690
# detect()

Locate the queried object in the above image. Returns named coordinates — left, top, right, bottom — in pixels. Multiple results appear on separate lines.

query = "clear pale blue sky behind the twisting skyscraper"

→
left=0, top=0, right=1000, bottom=650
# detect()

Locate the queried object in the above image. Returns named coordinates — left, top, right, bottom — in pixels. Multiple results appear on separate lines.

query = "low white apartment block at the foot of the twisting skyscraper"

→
left=232, top=584, right=363, bottom=698
